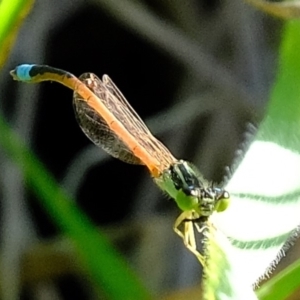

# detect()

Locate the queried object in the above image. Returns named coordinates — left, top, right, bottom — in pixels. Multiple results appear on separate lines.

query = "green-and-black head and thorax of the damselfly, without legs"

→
left=156, top=160, right=229, bottom=217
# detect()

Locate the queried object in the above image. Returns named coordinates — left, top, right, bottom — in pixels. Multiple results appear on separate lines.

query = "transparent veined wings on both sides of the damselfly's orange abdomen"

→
left=73, top=73, right=176, bottom=170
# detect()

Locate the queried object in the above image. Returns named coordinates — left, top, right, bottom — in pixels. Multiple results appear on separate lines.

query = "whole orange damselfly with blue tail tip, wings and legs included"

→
left=10, top=64, right=229, bottom=265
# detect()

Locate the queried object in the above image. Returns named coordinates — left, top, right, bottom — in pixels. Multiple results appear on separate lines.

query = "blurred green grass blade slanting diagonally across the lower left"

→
left=0, top=114, right=151, bottom=300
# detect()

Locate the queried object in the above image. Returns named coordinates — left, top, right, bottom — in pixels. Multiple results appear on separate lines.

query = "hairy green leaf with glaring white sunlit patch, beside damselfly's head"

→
left=205, top=21, right=300, bottom=299
